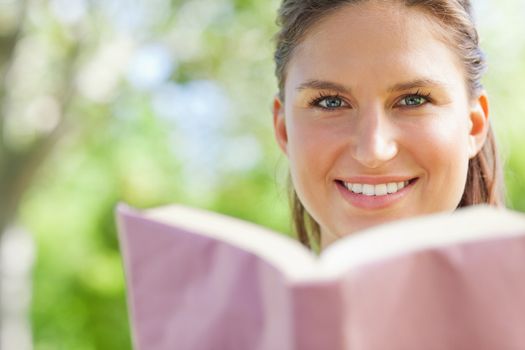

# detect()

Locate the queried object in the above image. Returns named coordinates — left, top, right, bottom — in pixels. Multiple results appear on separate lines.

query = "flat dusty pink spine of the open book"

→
left=291, top=280, right=344, bottom=350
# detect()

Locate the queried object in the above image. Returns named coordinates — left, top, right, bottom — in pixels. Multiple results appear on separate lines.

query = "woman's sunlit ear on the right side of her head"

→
left=469, top=91, right=490, bottom=158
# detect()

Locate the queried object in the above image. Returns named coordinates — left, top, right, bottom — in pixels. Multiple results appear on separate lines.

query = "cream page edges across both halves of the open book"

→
left=135, top=205, right=525, bottom=282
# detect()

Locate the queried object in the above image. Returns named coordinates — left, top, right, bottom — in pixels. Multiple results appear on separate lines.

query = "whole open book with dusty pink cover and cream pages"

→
left=116, top=204, right=525, bottom=350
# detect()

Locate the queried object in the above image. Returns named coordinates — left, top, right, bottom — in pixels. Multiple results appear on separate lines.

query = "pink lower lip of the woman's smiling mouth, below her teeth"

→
left=336, top=179, right=417, bottom=210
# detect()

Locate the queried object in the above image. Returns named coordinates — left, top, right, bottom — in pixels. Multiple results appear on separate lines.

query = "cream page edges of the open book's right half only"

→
left=320, top=206, right=525, bottom=278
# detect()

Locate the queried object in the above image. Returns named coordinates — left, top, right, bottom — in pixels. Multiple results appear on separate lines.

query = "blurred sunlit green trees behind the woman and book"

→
left=0, top=0, right=525, bottom=350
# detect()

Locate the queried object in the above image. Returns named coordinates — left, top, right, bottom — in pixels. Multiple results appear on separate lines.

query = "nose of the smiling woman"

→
left=352, top=107, right=398, bottom=168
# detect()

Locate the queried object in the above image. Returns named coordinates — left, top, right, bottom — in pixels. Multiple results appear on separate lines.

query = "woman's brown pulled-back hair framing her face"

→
left=275, top=0, right=504, bottom=248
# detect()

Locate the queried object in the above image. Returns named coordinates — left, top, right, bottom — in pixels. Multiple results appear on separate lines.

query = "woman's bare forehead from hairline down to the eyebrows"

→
left=288, top=0, right=463, bottom=90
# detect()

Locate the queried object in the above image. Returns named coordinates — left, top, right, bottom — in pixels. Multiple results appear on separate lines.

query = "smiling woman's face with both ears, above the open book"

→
left=274, top=1, right=488, bottom=247
